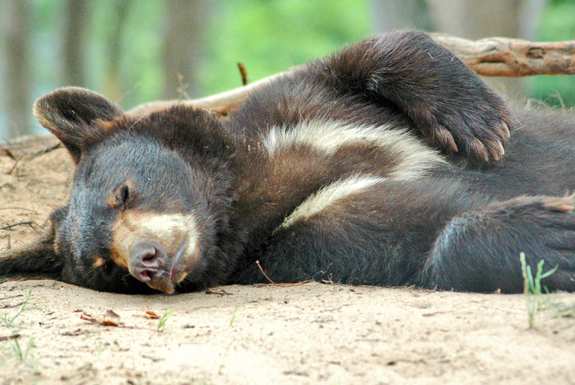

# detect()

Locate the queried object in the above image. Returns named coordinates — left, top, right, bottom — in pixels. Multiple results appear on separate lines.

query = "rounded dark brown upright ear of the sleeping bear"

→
left=34, top=87, right=123, bottom=163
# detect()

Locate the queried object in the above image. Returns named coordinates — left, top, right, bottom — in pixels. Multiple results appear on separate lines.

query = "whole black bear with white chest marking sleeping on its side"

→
left=0, top=32, right=575, bottom=293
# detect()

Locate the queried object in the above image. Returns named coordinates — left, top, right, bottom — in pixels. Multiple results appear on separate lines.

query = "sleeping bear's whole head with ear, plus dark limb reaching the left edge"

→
left=0, top=88, right=233, bottom=293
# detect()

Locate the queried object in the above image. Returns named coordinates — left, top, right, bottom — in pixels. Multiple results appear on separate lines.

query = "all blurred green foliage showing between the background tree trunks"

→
left=10, top=0, right=575, bottom=137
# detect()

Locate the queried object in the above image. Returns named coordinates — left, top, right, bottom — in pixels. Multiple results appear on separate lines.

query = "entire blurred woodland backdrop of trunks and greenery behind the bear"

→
left=0, top=0, right=575, bottom=139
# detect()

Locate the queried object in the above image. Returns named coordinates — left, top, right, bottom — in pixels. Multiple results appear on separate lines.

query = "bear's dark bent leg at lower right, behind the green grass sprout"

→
left=420, top=195, right=575, bottom=293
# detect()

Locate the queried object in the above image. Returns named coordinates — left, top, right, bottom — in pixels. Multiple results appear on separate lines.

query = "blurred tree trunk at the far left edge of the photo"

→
left=0, top=0, right=31, bottom=138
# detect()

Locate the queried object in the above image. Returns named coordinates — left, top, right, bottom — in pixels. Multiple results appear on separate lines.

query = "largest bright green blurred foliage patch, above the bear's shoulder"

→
left=200, top=0, right=371, bottom=94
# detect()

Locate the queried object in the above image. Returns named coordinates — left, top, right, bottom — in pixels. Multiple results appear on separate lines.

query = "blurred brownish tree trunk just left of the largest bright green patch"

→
left=162, top=0, right=213, bottom=99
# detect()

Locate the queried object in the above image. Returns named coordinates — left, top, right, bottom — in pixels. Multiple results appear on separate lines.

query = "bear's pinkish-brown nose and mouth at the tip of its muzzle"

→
left=129, top=241, right=174, bottom=293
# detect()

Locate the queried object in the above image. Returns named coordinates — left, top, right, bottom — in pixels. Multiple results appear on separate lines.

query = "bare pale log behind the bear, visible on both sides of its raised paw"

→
left=128, top=33, right=575, bottom=115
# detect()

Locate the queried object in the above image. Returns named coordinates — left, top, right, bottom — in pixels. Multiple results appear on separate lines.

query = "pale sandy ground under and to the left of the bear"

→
left=0, top=134, right=575, bottom=385
